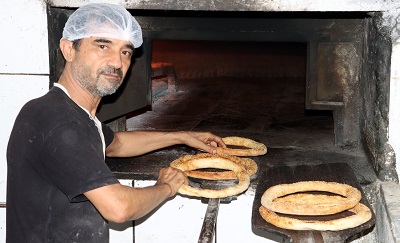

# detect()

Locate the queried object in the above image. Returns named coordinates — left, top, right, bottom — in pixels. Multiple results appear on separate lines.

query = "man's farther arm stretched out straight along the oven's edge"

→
left=106, top=131, right=226, bottom=157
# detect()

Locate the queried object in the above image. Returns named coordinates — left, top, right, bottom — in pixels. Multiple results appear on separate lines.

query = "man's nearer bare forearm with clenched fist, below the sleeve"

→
left=84, top=167, right=188, bottom=223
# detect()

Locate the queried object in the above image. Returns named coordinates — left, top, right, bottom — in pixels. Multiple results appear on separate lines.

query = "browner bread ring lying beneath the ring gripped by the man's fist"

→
left=171, top=153, right=258, bottom=180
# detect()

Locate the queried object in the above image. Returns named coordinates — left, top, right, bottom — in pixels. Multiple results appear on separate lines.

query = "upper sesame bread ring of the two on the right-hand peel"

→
left=261, top=181, right=361, bottom=215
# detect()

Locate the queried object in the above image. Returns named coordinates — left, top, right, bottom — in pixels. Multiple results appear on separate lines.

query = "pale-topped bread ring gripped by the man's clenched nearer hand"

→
left=171, top=157, right=250, bottom=198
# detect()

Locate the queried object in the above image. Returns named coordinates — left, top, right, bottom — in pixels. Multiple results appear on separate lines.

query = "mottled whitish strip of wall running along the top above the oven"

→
left=48, top=0, right=399, bottom=12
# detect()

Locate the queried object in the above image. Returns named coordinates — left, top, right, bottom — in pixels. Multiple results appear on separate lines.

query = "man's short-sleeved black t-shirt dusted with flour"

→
left=6, top=87, right=119, bottom=243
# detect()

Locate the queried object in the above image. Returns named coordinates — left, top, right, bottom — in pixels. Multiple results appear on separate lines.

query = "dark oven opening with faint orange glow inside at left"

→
left=127, top=40, right=334, bottom=153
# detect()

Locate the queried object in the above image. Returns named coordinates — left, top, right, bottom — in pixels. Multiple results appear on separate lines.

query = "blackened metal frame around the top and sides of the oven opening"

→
left=49, top=8, right=382, bottom=147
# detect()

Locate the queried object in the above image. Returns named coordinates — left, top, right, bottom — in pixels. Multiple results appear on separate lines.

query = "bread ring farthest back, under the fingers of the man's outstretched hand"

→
left=216, top=137, right=267, bottom=156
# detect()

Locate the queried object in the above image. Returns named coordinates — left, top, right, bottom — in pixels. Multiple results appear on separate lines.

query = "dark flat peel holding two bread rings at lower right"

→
left=252, top=163, right=375, bottom=243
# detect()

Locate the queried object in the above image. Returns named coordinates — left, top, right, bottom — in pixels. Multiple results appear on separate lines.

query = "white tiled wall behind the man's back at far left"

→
left=0, top=0, right=49, bottom=239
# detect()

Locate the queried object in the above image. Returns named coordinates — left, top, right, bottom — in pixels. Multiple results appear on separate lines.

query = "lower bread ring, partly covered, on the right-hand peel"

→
left=259, top=203, right=372, bottom=231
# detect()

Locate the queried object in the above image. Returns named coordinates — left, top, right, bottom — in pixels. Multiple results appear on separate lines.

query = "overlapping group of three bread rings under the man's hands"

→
left=170, top=137, right=267, bottom=198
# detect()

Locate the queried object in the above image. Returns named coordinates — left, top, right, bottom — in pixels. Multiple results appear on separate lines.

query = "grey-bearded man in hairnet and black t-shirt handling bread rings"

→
left=6, top=4, right=226, bottom=243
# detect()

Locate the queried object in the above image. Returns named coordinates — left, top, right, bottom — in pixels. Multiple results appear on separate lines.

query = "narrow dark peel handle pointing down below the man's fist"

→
left=198, top=198, right=220, bottom=243
